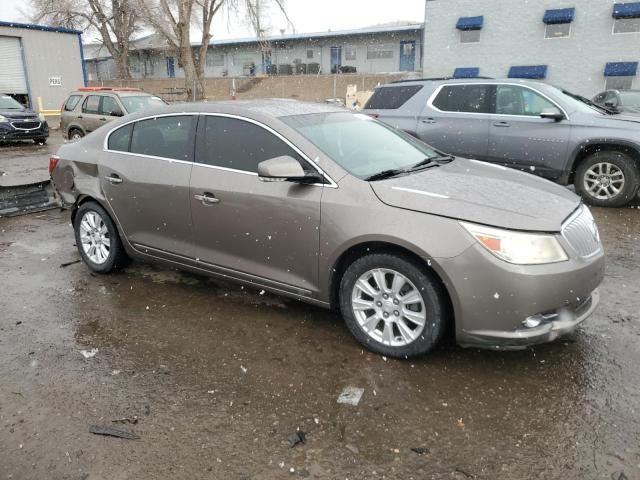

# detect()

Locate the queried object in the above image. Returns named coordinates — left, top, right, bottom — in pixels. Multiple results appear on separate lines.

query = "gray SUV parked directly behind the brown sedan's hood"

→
left=364, top=79, right=640, bottom=207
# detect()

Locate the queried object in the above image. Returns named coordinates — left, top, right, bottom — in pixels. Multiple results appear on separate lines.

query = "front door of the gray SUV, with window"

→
left=488, top=84, right=571, bottom=178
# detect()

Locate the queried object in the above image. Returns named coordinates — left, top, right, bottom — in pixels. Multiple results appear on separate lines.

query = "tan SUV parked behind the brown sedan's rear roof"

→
left=60, top=87, right=166, bottom=140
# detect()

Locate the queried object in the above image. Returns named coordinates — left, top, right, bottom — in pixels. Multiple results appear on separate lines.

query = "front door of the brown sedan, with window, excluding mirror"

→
left=190, top=115, right=323, bottom=296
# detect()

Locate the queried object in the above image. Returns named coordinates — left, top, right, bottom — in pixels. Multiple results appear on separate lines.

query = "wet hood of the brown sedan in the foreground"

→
left=370, top=159, right=580, bottom=232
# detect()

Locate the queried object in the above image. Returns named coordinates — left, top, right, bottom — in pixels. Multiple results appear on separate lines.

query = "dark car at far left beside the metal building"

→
left=0, top=95, right=49, bottom=143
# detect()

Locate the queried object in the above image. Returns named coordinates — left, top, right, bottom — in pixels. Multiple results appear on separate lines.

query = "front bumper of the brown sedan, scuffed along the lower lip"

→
left=439, top=242, right=604, bottom=349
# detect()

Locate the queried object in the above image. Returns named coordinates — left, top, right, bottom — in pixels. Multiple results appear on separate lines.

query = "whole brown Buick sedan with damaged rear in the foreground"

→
left=50, top=100, right=604, bottom=358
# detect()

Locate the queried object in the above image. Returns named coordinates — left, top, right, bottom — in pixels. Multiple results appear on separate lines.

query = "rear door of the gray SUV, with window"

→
left=417, top=83, right=494, bottom=160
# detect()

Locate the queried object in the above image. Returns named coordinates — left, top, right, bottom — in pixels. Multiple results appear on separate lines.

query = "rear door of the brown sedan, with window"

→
left=98, top=115, right=197, bottom=258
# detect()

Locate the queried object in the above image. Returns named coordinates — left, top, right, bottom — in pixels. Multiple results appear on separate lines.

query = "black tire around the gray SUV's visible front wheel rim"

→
left=574, top=150, right=640, bottom=207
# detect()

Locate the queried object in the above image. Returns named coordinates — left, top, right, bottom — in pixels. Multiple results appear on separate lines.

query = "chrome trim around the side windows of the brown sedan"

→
left=102, top=112, right=338, bottom=188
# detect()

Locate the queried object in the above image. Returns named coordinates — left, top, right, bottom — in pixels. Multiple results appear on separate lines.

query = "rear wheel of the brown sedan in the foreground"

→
left=73, top=202, right=127, bottom=273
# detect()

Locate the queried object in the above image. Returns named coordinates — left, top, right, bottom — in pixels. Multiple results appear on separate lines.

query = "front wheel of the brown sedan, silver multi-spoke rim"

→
left=340, top=253, right=447, bottom=358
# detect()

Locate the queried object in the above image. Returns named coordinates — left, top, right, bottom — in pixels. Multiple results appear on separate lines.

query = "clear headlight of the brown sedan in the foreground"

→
left=460, top=222, right=569, bottom=265
